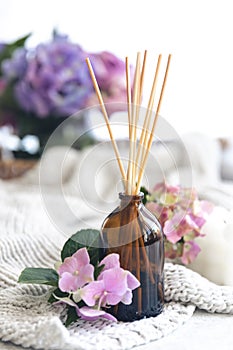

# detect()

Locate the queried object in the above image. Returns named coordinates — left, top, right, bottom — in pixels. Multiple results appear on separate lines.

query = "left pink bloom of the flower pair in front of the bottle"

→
left=58, top=248, right=94, bottom=292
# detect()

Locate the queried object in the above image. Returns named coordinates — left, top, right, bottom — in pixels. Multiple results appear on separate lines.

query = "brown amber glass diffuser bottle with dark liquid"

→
left=101, top=193, right=164, bottom=321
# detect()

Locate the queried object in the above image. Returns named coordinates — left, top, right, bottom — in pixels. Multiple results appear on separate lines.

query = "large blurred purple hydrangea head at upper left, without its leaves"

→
left=15, top=36, right=93, bottom=118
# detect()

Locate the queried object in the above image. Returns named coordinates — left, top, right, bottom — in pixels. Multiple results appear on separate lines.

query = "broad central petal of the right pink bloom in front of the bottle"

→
left=103, top=268, right=127, bottom=296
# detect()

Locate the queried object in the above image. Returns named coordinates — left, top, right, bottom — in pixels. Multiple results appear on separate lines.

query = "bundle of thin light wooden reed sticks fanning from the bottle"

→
left=86, top=50, right=171, bottom=195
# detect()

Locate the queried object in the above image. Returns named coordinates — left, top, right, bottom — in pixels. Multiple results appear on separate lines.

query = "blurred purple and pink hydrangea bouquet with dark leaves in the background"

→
left=0, top=33, right=126, bottom=155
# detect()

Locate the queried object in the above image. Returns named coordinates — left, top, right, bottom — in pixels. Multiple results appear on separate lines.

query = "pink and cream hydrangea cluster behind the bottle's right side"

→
left=142, top=183, right=213, bottom=265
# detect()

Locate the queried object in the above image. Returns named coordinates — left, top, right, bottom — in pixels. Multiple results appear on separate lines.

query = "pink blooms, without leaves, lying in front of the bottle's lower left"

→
left=54, top=252, right=140, bottom=321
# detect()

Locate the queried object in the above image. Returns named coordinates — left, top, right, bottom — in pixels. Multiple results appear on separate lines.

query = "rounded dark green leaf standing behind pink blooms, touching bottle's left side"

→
left=61, top=229, right=100, bottom=265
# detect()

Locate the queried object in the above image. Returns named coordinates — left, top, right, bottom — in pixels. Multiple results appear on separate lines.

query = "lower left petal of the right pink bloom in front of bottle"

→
left=81, top=281, right=104, bottom=306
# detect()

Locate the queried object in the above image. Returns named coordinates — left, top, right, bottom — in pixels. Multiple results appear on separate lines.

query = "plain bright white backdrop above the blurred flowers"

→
left=0, top=0, right=233, bottom=137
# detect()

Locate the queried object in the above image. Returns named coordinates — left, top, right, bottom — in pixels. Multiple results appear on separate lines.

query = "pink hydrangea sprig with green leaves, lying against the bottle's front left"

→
left=19, top=229, right=140, bottom=326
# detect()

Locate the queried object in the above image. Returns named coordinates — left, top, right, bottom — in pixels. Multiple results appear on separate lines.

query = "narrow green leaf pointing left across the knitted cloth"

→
left=18, top=267, right=58, bottom=287
